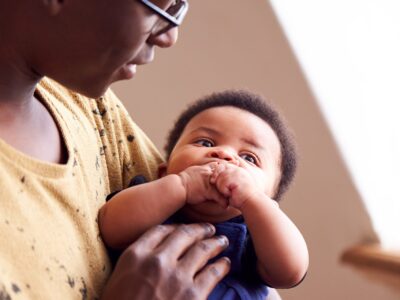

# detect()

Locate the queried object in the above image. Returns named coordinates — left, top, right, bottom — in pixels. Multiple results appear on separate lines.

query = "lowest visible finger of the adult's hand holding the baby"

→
left=194, top=257, right=231, bottom=299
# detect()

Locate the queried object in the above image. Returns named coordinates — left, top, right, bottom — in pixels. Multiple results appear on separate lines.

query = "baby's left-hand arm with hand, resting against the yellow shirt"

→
left=99, top=163, right=226, bottom=249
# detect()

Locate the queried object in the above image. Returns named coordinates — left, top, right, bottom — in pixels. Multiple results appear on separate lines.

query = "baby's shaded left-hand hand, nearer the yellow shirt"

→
left=178, top=162, right=228, bottom=207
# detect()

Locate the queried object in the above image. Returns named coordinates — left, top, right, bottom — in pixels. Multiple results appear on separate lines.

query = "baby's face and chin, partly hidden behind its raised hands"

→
left=167, top=106, right=281, bottom=222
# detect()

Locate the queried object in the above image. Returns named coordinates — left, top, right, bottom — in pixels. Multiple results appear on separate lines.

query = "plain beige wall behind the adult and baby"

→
left=114, top=0, right=400, bottom=300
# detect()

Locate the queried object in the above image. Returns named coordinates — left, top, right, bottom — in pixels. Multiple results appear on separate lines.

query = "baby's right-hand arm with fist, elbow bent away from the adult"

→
left=212, top=164, right=308, bottom=288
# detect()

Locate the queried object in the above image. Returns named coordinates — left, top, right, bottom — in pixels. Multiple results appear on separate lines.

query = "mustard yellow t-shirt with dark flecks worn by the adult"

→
left=0, top=79, right=161, bottom=300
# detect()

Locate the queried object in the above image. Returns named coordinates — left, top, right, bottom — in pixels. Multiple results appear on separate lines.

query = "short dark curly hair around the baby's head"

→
left=164, top=90, right=297, bottom=200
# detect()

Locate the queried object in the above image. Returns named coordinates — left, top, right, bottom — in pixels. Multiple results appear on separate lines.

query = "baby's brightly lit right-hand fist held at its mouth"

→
left=210, top=162, right=259, bottom=210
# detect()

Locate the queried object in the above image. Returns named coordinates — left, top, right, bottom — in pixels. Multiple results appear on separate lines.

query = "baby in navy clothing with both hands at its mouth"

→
left=99, top=91, right=308, bottom=299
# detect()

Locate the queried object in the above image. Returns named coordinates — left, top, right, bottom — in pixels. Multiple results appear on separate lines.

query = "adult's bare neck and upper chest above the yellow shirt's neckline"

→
left=0, top=46, right=67, bottom=163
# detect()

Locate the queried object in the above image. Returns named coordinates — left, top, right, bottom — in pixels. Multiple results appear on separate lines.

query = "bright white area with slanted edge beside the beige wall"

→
left=270, top=0, right=400, bottom=248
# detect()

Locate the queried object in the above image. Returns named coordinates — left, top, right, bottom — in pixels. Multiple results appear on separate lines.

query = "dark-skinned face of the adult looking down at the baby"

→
left=39, top=0, right=177, bottom=97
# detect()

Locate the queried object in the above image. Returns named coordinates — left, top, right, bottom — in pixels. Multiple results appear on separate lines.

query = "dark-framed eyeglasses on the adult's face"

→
left=140, top=0, right=189, bottom=35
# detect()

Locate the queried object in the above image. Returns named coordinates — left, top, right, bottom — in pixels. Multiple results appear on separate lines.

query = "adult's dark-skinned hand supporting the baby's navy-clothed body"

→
left=102, top=224, right=230, bottom=300
